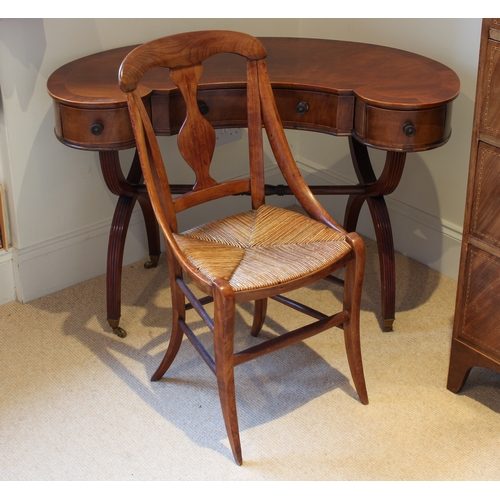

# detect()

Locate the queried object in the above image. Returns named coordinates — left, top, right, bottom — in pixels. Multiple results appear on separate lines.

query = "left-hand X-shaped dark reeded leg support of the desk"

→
left=99, top=151, right=160, bottom=338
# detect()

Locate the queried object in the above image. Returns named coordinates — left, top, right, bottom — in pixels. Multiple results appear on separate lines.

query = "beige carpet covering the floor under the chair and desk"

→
left=0, top=238, right=500, bottom=481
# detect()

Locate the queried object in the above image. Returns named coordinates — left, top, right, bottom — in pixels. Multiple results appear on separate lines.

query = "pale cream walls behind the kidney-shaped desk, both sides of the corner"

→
left=0, top=19, right=480, bottom=304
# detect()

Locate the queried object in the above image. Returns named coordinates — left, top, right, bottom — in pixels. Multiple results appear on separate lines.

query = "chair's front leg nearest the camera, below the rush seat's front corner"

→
left=214, top=282, right=243, bottom=465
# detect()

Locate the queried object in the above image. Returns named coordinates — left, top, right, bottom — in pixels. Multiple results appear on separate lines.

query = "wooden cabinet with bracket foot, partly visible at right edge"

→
left=447, top=19, right=500, bottom=392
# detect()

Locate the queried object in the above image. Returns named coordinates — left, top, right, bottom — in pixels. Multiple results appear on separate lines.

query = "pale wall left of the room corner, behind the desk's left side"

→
left=0, top=19, right=299, bottom=303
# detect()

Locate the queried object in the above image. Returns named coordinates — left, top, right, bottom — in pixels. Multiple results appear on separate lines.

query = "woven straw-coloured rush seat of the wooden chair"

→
left=175, top=205, right=351, bottom=291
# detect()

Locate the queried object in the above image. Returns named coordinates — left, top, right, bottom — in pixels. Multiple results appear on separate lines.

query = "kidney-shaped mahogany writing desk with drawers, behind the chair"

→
left=47, top=37, right=460, bottom=336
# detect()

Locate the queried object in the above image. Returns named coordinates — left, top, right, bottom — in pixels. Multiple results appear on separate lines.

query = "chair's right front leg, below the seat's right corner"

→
left=344, top=235, right=368, bottom=405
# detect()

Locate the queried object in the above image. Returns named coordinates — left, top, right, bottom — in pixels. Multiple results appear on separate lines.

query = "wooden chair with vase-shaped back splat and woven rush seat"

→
left=119, top=31, right=368, bottom=465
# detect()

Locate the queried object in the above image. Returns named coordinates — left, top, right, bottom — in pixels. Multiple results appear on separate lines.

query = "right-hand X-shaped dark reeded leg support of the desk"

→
left=344, top=137, right=406, bottom=331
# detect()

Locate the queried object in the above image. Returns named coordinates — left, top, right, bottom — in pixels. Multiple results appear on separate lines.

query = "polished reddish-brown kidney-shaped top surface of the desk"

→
left=47, top=37, right=460, bottom=109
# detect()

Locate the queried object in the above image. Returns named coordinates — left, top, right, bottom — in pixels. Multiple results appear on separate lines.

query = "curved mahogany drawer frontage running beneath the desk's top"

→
left=55, top=89, right=452, bottom=151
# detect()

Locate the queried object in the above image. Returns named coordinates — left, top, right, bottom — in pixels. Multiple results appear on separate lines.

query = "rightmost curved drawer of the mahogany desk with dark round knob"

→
left=353, top=101, right=452, bottom=152
